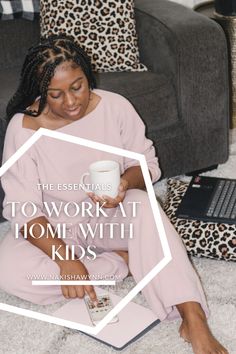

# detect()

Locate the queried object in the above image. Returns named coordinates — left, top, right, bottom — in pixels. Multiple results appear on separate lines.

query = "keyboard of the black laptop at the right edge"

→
left=206, top=180, right=236, bottom=220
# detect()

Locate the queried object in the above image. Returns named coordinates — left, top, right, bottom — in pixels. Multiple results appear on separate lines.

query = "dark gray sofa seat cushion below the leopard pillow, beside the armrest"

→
left=97, top=71, right=180, bottom=133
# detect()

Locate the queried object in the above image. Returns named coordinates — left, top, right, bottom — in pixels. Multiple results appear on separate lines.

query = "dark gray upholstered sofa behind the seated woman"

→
left=0, top=0, right=229, bottom=218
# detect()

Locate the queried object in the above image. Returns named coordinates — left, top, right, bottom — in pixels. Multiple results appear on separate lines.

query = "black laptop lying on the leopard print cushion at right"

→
left=176, top=176, right=236, bottom=224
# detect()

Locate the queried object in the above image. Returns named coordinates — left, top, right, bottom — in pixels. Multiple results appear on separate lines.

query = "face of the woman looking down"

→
left=47, top=62, right=90, bottom=121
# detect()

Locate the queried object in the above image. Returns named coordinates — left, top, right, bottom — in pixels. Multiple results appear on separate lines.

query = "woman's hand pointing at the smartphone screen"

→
left=58, top=260, right=97, bottom=302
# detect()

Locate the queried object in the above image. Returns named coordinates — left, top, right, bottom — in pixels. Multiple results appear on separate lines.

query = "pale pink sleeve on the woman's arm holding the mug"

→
left=120, top=99, right=161, bottom=183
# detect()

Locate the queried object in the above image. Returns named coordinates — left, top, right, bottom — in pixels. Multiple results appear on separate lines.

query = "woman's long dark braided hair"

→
left=6, top=34, right=95, bottom=122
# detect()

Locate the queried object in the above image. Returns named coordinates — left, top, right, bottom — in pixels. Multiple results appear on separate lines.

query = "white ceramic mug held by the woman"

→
left=80, top=160, right=120, bottom=198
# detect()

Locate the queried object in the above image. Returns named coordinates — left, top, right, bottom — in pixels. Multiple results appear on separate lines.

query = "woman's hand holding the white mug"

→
left=88, top=178, right=128, bottom=208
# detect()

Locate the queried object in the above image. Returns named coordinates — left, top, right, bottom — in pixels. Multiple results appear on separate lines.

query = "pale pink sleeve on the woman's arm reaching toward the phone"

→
left=1, top=115, right=44, bottom=229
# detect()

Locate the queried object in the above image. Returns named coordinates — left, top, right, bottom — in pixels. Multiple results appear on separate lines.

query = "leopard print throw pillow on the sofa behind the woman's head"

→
left=40, top=0, right=147, bottom=72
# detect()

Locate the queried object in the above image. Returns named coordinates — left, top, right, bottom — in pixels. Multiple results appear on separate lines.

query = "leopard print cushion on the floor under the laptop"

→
left=163, top=179, right=236, bottom=261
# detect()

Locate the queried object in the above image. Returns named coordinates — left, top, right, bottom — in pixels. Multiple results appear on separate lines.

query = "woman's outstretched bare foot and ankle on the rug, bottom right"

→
left=177, top=302, right=229, bottom=354
